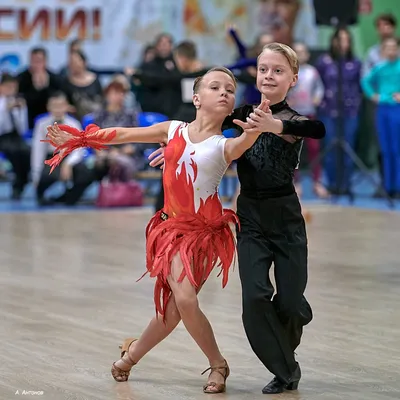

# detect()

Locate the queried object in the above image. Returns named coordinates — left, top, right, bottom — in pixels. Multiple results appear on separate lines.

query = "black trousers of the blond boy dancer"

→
left=237, top=193, right=313, bottom=383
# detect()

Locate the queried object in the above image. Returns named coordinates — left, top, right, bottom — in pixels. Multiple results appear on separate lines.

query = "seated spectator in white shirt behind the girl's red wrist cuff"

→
left=31, top=92, right=88, bottom=206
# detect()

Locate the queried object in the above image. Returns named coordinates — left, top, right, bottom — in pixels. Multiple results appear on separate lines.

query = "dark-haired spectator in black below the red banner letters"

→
left=18, top=47, right=60, bottom=129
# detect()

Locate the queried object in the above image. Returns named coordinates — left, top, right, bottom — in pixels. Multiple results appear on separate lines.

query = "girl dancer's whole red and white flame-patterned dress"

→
left=146, top=121, right=239, bottom=315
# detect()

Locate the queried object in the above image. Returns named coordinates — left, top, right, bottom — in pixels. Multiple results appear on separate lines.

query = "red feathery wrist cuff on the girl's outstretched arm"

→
left=41, top=124, right=117, bottom=173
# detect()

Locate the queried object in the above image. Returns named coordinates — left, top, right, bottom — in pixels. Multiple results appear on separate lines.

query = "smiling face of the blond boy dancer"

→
left=257, top=50, right=297, bottom=104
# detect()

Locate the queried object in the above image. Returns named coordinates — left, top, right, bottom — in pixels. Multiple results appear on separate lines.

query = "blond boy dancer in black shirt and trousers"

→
left=151, top=43, right=325, bottom=394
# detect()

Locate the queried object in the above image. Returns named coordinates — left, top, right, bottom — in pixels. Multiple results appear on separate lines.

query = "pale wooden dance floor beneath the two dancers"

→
left=0, top=206, right=400, bottom=400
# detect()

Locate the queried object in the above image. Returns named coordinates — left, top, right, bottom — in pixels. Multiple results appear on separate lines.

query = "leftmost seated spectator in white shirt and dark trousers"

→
left=0, top=74, right=30, bottom=200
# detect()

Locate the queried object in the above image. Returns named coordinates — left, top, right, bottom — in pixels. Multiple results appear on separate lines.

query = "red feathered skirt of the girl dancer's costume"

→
left=140, top=209, right=239, bottom=319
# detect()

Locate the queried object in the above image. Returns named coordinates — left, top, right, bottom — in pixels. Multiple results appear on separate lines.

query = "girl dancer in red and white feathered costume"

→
left=47, top=68, right=274, bottom=393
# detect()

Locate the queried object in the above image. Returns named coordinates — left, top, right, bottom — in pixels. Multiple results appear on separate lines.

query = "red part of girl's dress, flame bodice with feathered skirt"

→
left=146, top=124, right=239, bottom=318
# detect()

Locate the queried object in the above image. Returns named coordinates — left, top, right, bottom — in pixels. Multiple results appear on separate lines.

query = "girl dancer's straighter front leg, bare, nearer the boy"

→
left=168, top=253, right=225, bottom=391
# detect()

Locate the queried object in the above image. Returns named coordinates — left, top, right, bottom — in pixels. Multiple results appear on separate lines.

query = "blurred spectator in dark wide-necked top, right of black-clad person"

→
left=62, top=51, right=103, bottom=121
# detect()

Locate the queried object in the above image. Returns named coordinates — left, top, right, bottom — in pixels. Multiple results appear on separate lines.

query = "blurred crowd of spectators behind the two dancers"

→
left=0, top=10, right=400, bottom=205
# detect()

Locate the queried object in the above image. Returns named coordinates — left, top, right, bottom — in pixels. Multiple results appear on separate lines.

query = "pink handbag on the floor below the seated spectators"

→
left=96, top=164, right=144, bottom=207
